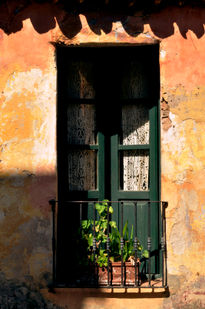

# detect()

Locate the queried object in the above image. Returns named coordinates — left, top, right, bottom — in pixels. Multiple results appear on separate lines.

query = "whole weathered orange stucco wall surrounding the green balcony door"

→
left=0, top=4, right=205, bottom=309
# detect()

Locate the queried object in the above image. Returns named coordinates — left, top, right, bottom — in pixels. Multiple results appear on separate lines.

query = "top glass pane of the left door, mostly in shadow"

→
left=67, top=61, right=95, bottom=99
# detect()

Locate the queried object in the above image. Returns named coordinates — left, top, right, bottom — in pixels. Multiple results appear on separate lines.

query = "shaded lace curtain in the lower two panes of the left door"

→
left=67, top=104, right=97, bottom=191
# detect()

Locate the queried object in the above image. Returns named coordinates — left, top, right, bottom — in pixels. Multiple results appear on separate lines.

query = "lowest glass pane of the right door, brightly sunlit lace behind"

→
left=120, top=150, right=149, bottom=191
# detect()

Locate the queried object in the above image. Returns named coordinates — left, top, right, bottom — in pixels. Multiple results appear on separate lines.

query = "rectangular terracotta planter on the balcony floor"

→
left=97, top=262, right=139, bottom=285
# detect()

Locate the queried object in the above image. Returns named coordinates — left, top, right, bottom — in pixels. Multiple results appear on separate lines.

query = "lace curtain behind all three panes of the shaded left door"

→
left=67, top=61, right=97, bottom=191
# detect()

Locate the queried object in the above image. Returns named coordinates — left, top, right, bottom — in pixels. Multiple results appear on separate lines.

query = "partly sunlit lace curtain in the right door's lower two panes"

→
left=122, top=105, right=149, bottom=191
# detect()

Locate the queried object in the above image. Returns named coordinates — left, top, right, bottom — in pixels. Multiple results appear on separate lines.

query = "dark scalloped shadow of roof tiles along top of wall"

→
left=0, top=1, right=205, bottom=39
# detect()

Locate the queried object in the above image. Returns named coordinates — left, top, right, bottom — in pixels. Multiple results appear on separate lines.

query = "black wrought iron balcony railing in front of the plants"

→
left=49, top=200, right=168, bottom=288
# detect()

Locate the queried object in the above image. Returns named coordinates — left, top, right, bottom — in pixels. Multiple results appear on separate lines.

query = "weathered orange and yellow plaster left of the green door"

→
left=0, top=9, right=56, bottom=284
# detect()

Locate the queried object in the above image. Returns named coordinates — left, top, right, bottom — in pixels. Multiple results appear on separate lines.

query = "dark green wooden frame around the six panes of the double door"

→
left=57, top=45, right=160, bottom=282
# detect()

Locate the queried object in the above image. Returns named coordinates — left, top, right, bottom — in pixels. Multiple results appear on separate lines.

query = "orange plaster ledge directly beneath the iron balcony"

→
left=41, top=288, right=169, bottom=309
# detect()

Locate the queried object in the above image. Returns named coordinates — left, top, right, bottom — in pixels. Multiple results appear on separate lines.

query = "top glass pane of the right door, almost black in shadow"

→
left=120, top=60, right=152, bottom=99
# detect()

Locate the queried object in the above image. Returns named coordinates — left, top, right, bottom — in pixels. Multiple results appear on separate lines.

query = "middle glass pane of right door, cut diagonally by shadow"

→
left=121, top=104, right=149, bottom=145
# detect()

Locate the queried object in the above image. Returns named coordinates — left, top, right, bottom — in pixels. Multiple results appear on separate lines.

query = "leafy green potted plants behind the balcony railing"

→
left=81, top=200, right=149, bottom=267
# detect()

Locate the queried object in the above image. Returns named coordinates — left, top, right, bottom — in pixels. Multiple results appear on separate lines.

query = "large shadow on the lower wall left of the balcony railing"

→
left=0, top=171, right=56, bottom=282
